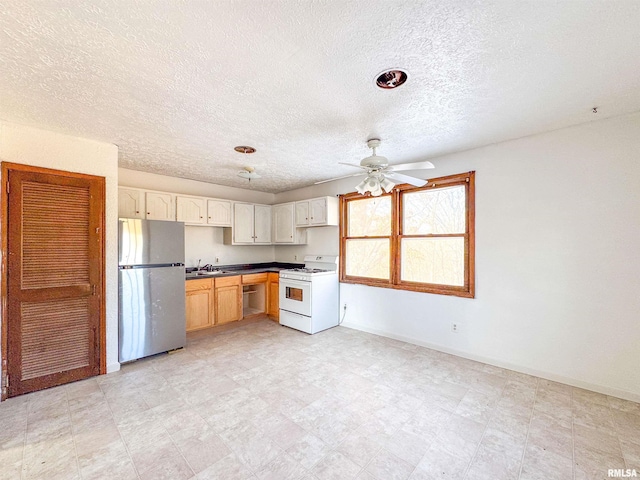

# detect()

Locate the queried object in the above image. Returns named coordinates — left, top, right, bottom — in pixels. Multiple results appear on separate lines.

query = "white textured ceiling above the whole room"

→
left=0, top=0, right=640, bottom=192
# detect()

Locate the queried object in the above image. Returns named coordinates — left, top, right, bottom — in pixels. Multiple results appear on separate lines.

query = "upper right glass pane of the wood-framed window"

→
left=402, top=185, right=466, bottom=235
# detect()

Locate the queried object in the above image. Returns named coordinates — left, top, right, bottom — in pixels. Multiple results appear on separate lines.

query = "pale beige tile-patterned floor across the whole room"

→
left=0, top=319, right=640, bottom=480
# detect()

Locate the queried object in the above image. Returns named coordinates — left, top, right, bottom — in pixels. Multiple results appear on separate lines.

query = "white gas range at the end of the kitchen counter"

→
left=280, top=255, right=340, bottom=333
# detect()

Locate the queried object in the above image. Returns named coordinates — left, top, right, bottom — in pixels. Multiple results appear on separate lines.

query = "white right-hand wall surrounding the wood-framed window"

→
left=276, top=114, right=640, bottom=401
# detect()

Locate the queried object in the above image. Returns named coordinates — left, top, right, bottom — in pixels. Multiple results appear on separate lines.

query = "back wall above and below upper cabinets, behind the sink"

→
left=118, top=168, right=275, bottom=267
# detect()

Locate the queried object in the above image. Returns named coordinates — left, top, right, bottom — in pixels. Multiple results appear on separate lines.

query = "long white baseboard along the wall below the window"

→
left=341, top=322, right=640, bottom=403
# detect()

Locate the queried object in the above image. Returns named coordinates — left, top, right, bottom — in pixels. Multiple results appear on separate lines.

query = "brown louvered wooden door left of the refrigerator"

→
left=7, top=165, right=104, bottom=396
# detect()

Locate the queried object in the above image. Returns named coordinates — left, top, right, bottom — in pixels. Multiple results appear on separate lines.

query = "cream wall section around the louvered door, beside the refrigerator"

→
left=0, top=121, right=120, bottom=372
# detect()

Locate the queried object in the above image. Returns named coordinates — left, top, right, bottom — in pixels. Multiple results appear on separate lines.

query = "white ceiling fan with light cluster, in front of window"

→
left=315, top=138, right=434, bottom=197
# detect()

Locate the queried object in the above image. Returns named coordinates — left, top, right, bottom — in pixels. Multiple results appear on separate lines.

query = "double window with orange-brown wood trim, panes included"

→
left=340, top=172, right=475, bottom=298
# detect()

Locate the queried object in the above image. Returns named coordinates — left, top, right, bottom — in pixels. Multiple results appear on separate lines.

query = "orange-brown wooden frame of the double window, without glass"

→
left=340, top=171, right=475, bottom=298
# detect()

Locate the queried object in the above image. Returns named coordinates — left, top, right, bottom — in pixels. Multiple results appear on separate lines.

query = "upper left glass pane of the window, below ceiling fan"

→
left=347, top=197, right=391, bottom=237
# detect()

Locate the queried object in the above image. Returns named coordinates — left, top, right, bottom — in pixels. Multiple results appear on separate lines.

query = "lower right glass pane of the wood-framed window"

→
left=401, top=237, right=464, bottom=286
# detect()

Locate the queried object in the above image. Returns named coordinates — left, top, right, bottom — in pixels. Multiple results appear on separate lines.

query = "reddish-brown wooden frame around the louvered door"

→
left=0, top=162, right=107, bottom=401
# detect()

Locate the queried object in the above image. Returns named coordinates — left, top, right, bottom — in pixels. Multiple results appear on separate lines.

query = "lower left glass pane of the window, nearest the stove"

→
left=346, top=238, right=389, bottom=280
